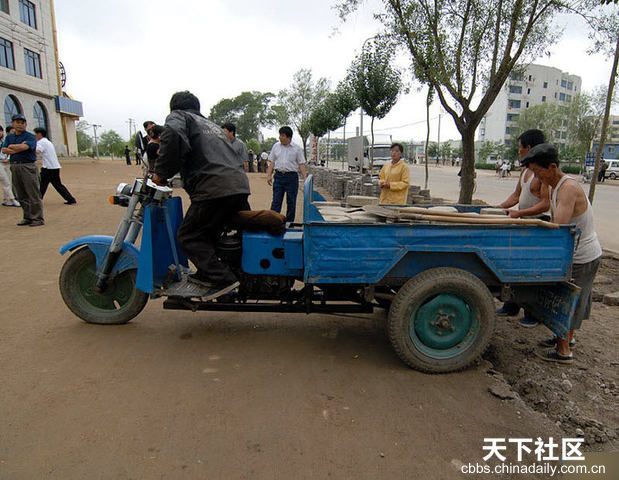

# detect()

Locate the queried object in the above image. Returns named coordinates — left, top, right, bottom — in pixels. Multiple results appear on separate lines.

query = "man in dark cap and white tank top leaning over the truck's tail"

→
left=521, top=143, right=602, bottom=363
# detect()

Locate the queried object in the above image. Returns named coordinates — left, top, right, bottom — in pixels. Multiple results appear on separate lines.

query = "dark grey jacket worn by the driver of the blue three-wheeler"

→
left=155, top=110, right=250, bottom=201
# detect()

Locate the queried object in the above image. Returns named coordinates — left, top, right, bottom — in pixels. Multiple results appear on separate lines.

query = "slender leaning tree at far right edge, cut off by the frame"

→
left=589, top=6, right=619, bottom=203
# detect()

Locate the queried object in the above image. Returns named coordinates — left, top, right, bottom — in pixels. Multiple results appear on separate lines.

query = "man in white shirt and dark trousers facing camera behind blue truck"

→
left=267, top=127, right=307, bottom=223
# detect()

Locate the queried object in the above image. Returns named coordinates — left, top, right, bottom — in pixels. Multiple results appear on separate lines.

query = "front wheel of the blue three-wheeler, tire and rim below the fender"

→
left=59, top=247, right=148, bottom=325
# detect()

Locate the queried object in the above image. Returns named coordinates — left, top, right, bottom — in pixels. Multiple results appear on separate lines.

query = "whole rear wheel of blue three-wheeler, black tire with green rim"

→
left=388, top=268, right=496, bottom=373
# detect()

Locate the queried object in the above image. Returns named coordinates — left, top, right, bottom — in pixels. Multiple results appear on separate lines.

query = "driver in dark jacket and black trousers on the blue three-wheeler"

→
left=153, top=91, right=250, bottom=299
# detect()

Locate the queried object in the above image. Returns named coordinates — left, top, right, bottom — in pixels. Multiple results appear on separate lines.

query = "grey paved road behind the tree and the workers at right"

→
left=411, top=165, right=619, bottom=251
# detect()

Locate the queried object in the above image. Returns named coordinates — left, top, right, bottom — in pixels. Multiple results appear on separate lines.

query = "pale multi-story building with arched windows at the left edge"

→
left=0, top=0, right=83, bottom=155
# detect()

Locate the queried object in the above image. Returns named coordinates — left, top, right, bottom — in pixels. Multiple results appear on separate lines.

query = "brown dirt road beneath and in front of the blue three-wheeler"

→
left=0, top=161, right=616, bottom=480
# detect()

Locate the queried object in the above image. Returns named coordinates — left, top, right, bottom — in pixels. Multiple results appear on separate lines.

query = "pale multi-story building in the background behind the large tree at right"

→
left=478, top=64, right=582, bottom=144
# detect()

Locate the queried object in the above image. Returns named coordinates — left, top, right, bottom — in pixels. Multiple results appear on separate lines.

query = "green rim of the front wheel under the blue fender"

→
left=73, top=255, right=136, bottom=313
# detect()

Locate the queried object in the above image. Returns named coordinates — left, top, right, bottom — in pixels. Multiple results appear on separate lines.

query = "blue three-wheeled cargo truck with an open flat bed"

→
left=60, top=175, right=579, bottom=373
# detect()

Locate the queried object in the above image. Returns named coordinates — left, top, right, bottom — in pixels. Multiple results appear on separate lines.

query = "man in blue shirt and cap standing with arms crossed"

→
left=2, top=114, right=45, bottom=227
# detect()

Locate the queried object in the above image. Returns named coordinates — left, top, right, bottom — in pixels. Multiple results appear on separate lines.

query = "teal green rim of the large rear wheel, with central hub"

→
left=409, top=293, right=480, bottom=360
